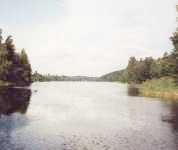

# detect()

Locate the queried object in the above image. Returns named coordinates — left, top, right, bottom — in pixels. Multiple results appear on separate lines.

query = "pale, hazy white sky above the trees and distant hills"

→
left=0, top=0, right=178, bottom=76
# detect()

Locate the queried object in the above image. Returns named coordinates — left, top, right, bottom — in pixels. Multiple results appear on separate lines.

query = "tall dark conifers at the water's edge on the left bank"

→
left=0, top=29, right=32, bottom=86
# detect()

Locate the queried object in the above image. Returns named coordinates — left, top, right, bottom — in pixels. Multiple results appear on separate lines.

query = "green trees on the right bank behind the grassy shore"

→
left=126, top=32, right=178, bottom=83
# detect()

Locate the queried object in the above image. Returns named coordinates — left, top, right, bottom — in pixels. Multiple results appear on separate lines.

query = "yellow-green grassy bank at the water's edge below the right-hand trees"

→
left=139, top=77, right=178, bottom=101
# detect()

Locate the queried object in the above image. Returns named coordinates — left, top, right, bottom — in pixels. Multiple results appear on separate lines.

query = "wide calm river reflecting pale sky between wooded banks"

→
left=0, top=82, right=178, bottom=150
